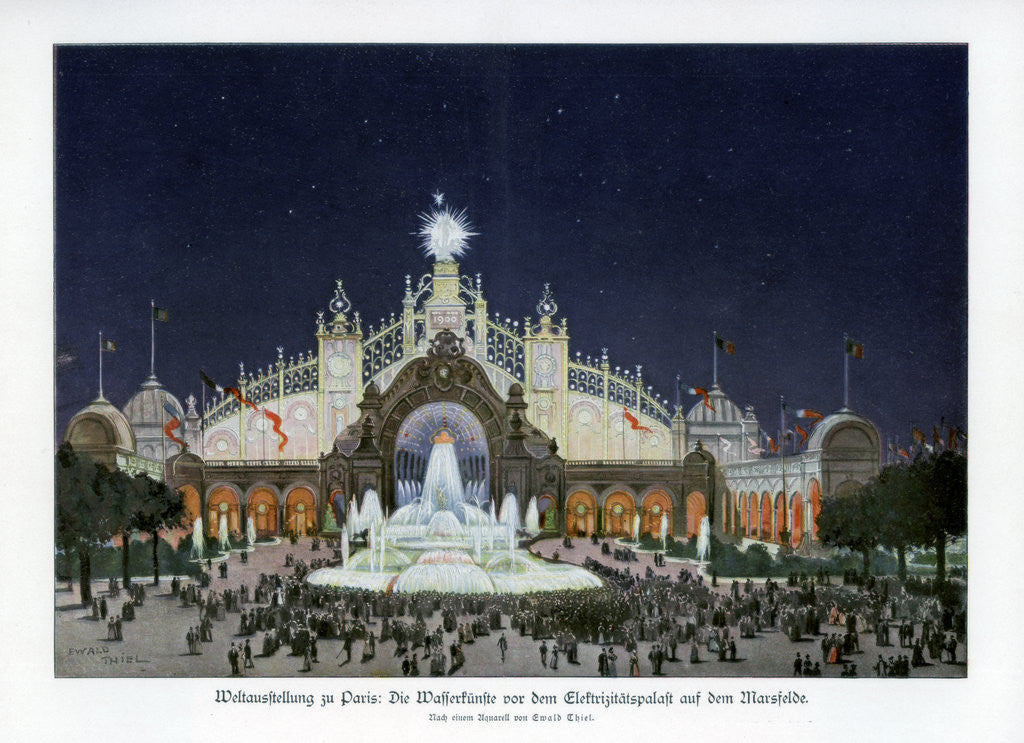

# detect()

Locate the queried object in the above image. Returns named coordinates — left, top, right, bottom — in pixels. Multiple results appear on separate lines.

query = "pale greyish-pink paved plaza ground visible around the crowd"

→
left=54, top=539, right=967, bottom=683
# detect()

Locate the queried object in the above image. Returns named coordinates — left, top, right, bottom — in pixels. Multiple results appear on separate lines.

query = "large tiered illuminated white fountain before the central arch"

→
left=307, top=428, right=602, bottom=594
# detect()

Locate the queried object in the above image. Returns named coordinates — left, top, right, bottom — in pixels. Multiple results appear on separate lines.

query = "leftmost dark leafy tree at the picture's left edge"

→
left=54, top=442, right=114, bottom=604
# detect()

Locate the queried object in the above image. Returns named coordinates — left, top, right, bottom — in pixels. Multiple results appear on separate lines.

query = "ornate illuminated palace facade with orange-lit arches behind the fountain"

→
left=65, top=244, right=881, bottom=550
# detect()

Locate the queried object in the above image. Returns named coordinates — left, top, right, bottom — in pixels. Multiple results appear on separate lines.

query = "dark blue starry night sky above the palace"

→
left=55, top=45, right=968, bottom=454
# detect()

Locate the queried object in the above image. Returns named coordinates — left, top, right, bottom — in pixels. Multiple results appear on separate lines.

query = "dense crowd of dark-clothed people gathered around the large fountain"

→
left=79, top=528, right=966, bottom=676
